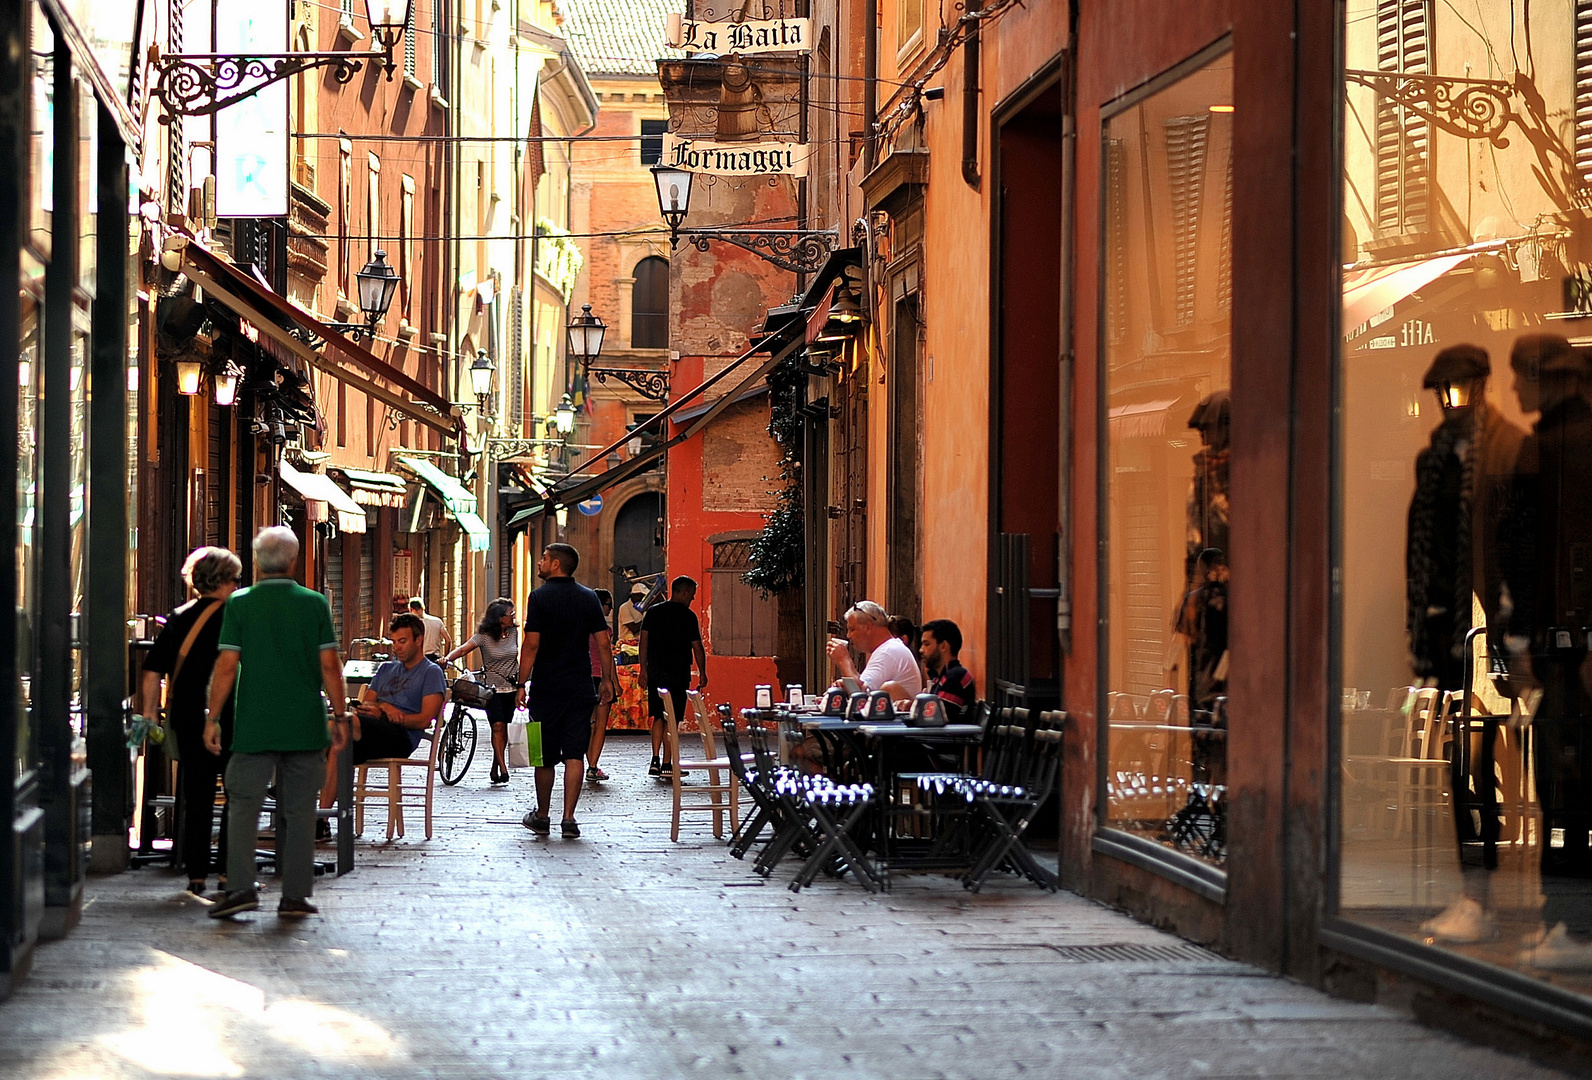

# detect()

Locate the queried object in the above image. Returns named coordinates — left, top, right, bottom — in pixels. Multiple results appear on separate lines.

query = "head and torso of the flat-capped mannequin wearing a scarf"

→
left=1404, top=346, right=1525, bottom=690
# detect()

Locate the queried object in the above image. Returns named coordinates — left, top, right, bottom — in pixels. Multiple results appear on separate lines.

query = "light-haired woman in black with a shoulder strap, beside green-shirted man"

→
left=142, top=548, right=244, bottom=895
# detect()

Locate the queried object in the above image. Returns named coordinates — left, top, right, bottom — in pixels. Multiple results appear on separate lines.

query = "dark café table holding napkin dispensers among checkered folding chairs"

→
left=778, top=710, right=984, bottom=887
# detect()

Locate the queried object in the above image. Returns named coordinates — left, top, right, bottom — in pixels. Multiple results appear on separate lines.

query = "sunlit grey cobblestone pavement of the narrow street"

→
left=0, top=738, right=1579, bottom=1080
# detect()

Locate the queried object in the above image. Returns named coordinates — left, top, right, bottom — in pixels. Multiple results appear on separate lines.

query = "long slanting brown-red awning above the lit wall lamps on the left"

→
left=175, top=236, right=458, bottom=436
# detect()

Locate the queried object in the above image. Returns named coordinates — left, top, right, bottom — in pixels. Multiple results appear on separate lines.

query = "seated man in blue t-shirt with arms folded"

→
left=320, top=613, right=447, bottom=808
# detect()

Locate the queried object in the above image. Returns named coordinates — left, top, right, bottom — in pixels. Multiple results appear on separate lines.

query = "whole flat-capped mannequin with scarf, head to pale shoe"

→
left=1404, top=344, right=1525, bottom=943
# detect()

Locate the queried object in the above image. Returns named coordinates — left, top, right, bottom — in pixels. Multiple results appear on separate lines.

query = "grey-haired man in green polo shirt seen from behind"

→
left=204, top=526, right=349, bottom=919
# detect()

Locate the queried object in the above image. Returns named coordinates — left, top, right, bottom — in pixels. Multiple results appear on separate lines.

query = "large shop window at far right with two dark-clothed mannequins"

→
left=1336, top=0, right=1592, bottom=992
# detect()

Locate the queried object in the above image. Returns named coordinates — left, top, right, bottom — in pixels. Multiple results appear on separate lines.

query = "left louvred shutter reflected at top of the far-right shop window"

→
left=1377, top=0, right=1431, bottom=236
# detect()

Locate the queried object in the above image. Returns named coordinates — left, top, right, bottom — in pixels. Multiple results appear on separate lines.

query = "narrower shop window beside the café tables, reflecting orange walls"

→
left=1100, top=54, right=1242, bottom=862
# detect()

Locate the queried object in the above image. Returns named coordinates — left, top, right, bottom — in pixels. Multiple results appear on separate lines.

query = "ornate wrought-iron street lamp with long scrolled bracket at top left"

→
left=153, top=0, right=412, bottom=124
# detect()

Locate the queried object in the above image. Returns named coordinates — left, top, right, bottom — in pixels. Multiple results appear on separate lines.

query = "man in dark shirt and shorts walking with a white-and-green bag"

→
left=519, top=543, right=618, bottom=839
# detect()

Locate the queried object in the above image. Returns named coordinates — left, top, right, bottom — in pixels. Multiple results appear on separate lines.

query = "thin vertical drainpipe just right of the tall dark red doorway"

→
left=1055, top=0, right=1078, bottom=656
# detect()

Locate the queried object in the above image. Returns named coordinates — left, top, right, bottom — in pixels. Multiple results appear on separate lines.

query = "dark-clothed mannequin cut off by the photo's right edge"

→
left=1498, top=335, right=1592, bottom=972
